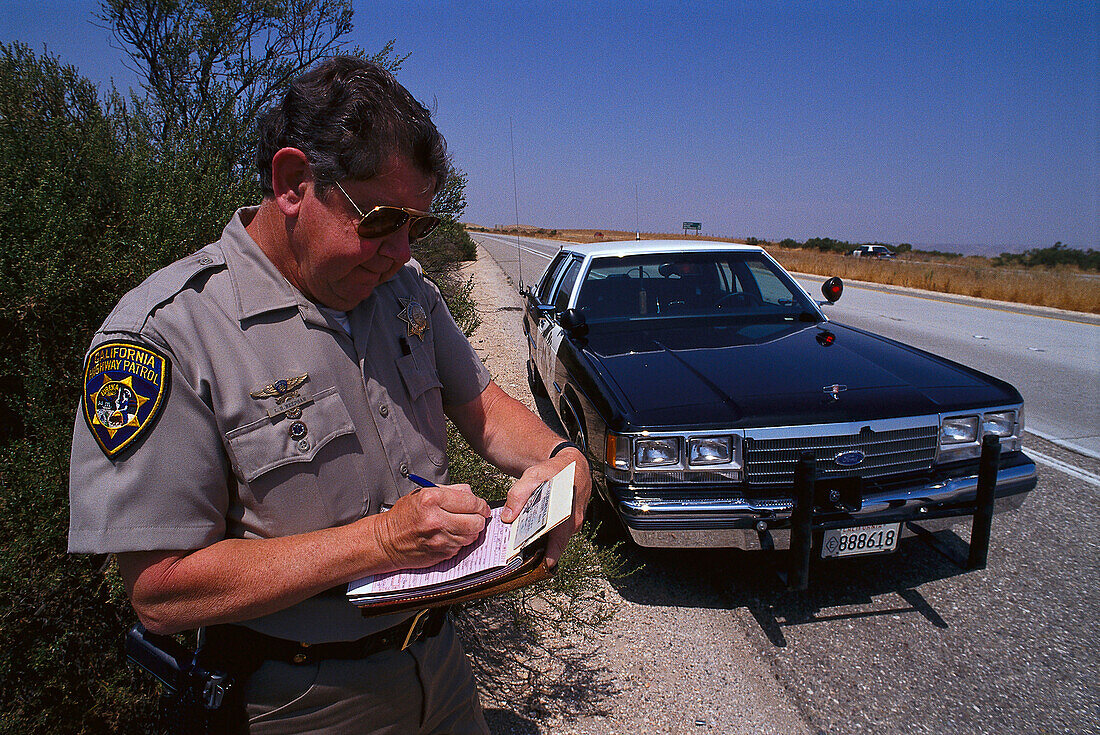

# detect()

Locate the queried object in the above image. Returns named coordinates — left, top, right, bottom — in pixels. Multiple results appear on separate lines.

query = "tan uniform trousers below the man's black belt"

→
left=245, top=621, right=488, bottom=735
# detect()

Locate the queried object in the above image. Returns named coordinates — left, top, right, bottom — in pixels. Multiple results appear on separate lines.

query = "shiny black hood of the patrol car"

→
left=584, top=321, right=1020, bottom=428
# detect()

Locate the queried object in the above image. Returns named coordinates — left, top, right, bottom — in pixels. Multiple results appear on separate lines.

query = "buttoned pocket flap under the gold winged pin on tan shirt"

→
left=226, top=386, right=355, bottom=483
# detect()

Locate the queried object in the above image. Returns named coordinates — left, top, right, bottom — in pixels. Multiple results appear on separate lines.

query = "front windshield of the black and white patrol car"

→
left=576, top=251, right=817, bottom=322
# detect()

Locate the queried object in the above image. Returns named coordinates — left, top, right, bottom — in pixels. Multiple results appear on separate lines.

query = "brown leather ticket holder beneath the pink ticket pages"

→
left=358, top=538, right=553, bottom=617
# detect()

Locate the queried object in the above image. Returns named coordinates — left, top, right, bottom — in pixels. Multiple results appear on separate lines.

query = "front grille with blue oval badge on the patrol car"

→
left=745, top=426, right=938, bottom=486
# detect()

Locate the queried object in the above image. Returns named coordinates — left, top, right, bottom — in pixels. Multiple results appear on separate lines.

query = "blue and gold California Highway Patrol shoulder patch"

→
left=83, top=342, right=172, bottom=457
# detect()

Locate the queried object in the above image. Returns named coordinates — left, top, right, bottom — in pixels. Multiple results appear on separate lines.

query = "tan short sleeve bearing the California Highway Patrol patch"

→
left=68, top=333, right=229, bottom=553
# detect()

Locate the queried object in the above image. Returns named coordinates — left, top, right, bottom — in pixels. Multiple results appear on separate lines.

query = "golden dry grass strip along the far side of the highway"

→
left=468, top=226, right=1100, bottom=314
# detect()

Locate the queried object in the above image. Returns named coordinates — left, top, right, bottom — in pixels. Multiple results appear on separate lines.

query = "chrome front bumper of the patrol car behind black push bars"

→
left=615, top=457, right=1036, bottom=550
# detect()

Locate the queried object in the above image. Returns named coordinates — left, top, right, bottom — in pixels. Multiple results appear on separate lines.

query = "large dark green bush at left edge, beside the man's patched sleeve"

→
left=0, top=44, right=193, bottom=733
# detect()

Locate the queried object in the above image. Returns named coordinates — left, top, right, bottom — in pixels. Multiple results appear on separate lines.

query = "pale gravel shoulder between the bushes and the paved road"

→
left=455, top=248, right=814, bottom=735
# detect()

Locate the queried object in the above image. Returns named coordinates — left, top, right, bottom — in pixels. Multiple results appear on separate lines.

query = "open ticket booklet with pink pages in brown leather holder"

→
left=348, top=462, right=576, bottom=615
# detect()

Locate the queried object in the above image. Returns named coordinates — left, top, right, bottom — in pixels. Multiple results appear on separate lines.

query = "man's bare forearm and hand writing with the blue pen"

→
left=119, top=485, right=490, bottom=633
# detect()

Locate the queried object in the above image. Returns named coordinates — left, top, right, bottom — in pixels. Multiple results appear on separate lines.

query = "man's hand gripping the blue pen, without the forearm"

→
left=372, top=485, right=490, bottom=570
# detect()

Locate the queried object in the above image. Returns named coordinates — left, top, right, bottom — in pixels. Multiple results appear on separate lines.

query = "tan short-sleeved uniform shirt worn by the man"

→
left=63, top=208, right=490, bottom=643
